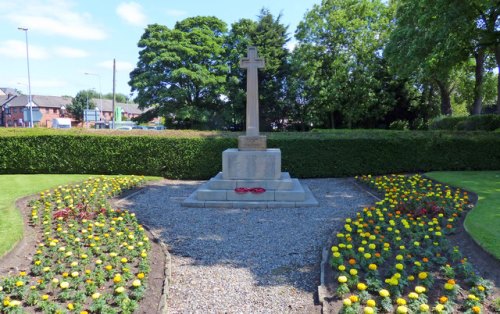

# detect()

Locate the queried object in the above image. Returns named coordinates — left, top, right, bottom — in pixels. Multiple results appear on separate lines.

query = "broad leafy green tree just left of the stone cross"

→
left=129, top=16, right=228, bottom=128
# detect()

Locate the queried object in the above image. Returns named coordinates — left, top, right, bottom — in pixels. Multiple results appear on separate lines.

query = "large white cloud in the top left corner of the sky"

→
left=4, top=0, right=107, bottom=40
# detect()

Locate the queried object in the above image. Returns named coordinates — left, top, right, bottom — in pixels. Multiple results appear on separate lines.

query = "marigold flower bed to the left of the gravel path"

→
left=0, top=176, right=150, bottom=313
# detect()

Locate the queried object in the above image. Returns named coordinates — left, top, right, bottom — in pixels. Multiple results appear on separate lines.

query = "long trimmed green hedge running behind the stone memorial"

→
left=0, top=132, right=500, bottom=179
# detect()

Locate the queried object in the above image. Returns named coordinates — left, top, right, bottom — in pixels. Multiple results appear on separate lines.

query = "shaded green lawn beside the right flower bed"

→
left=426, top=171, right=500, bottom=259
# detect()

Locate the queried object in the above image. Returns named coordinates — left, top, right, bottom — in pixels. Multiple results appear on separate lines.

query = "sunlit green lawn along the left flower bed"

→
left=0, top=174, right=159, bottom=257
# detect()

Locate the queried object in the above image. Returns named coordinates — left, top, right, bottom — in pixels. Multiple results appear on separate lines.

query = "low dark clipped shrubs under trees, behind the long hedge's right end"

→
left=430, top=114, right=500, bottom=131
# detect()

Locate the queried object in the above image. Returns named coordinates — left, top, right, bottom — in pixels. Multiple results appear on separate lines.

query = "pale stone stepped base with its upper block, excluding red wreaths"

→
left=182, top=149, right=318, bottom=208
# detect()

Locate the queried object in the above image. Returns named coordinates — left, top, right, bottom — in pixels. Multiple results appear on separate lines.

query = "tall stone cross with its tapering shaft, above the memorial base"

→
left=240, top=47, right=264, bottom=136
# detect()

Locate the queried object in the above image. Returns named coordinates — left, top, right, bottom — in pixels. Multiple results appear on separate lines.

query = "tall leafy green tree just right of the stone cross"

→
left=294, top=0, right=391, bottom=127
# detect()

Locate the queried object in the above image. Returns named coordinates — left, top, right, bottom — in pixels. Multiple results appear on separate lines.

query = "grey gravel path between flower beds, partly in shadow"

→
left=127, top=179, right=373, bottom=313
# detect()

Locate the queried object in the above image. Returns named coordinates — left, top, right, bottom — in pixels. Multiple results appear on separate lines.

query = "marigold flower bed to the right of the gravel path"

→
left=330, top=175, right=492, bottom=314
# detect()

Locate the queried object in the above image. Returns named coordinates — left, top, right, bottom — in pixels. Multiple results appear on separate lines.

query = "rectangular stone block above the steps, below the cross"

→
left=222, top=148, right=281, bottom=180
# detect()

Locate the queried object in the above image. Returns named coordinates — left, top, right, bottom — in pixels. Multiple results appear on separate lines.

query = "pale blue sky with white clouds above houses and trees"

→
left=0, top=0, right=321, bottom=96
